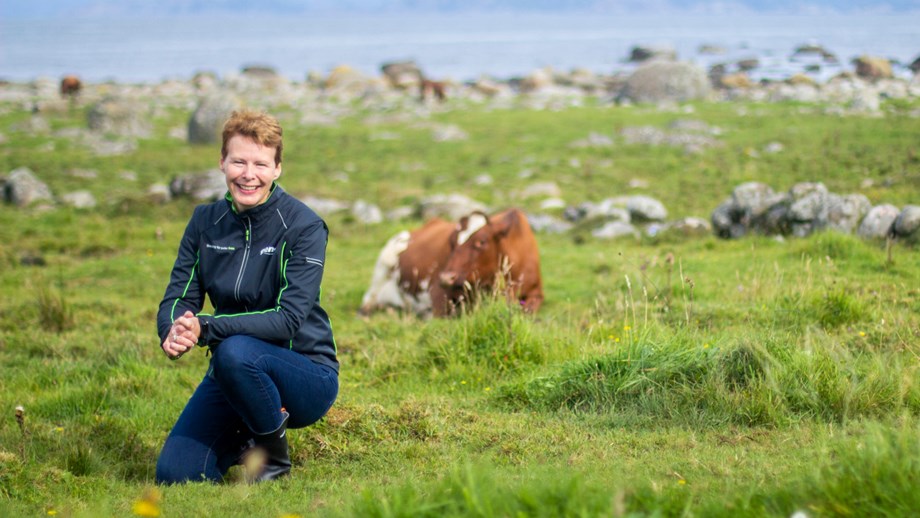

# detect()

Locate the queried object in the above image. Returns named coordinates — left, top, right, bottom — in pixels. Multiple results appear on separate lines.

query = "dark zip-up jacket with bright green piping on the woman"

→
left=157, top=185, right=339, bottom=371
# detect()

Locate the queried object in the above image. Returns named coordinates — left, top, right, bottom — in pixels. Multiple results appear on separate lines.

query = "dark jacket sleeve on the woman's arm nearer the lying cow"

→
left=198, top=221, right=329, bottom=347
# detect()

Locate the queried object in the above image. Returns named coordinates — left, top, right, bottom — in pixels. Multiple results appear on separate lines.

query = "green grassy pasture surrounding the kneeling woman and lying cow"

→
left=0, top=91, right=920, bottom=517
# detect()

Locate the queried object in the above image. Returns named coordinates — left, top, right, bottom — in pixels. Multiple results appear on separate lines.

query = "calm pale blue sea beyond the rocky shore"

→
left=0, top=11, right=920, bottom=83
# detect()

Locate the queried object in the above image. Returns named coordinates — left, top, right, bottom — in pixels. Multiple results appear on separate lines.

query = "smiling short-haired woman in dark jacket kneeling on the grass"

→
left=156, top=111, right=339, bottom=483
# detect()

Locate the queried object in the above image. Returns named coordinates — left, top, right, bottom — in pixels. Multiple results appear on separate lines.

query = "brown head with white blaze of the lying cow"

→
left=439, top=211, right=516, bottom=299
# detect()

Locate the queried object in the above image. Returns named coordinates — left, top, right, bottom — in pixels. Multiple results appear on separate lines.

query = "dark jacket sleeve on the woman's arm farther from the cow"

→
left=157, top=209, right=204, bottom=343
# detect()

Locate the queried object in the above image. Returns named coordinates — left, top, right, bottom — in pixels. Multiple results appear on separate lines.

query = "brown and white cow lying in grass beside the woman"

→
left=360, top=209, right=543, bottom=317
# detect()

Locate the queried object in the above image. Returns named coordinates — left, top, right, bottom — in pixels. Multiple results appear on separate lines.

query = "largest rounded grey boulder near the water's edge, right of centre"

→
left=622, top=60, right=710, bottom=102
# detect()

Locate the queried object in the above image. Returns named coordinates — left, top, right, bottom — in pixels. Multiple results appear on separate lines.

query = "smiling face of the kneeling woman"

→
left=220, top=135, right=281, bottom=212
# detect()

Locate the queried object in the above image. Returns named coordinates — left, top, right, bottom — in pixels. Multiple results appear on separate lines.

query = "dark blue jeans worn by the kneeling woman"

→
left=156, top=335, right=339, bottom=484
